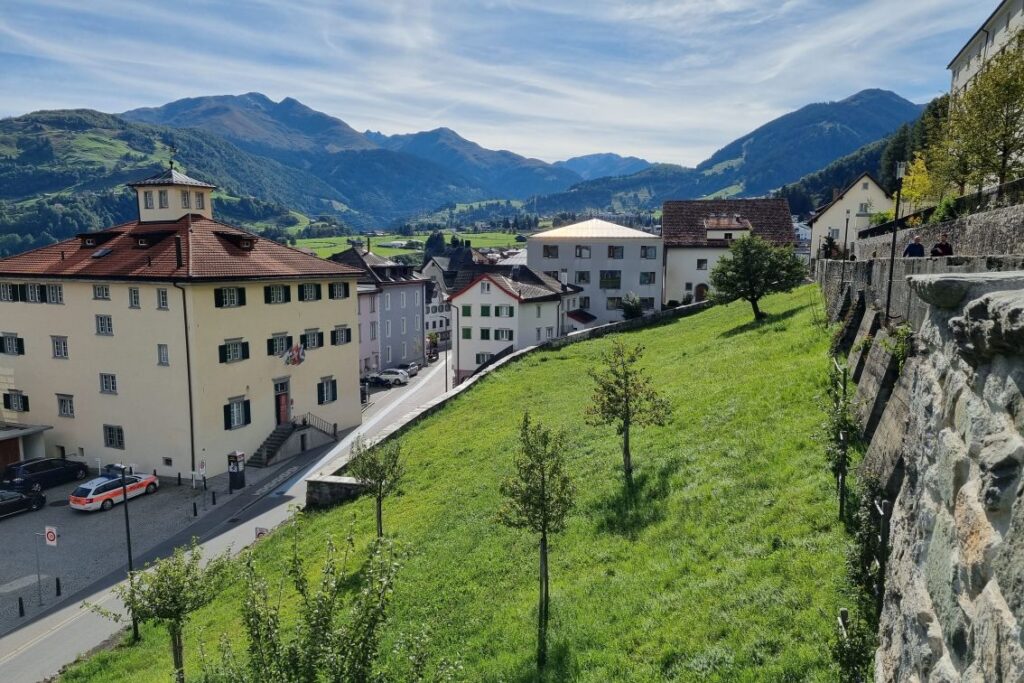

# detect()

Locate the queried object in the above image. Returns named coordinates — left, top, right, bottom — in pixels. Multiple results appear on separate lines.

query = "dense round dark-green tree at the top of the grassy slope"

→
left=711, top=236, right=807, bottom=319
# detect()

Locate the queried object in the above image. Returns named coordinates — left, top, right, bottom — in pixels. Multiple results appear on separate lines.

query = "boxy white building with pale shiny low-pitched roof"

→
left=526, top=218, right=664, bottom=325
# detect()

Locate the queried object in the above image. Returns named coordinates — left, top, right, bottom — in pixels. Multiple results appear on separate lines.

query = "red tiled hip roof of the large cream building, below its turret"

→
left=0, top=214, right=359, bottom=282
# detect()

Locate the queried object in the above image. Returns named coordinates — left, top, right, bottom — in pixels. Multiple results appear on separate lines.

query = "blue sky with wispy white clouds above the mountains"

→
left=0, top=0, right=997, bottom=165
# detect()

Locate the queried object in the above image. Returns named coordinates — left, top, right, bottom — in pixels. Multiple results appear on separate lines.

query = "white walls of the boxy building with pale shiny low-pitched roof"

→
left=526, top=236, right=664, bottom=325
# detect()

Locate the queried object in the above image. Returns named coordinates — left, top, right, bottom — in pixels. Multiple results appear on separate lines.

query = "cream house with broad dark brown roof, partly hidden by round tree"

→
left=662, top=199, right=796, bottom=302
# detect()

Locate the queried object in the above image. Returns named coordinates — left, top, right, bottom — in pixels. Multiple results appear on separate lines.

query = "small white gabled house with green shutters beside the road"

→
left=449, top=265, right=579, bottom=384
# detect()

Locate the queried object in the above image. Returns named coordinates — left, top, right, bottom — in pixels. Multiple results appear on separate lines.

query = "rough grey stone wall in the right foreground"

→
left=865, top=272, right=1024, bottom=683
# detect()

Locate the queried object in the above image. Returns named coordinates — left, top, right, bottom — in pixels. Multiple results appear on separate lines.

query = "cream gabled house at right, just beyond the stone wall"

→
left=808, top=173, right=892, bottom=258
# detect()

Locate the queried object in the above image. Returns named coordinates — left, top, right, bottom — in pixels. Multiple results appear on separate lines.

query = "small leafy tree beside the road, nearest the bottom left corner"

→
left=92, top=538, right=231, bottom=682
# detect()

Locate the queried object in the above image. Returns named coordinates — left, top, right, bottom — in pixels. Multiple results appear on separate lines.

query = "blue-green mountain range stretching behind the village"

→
left=0, top=90, right=921, bottom=249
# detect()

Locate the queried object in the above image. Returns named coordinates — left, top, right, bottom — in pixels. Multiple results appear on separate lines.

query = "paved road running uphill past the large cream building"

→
left=0, top=356, right=451, bottom=683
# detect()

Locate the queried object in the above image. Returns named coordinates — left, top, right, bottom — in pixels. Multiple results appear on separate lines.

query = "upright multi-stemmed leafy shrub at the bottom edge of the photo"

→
left=201, top=538, right=399, bottom=683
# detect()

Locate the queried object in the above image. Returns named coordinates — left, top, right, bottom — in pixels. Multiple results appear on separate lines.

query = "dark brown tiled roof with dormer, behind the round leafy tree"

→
left=662, top=199, right=796, bottom=247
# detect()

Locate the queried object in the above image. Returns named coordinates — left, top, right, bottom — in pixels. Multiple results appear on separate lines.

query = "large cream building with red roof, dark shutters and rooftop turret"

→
left=0, top=169, right=360, bottom=476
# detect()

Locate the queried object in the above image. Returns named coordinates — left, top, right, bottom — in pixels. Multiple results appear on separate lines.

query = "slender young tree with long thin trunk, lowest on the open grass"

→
left=498, top=413, right=574, bottom=670
